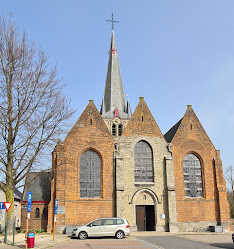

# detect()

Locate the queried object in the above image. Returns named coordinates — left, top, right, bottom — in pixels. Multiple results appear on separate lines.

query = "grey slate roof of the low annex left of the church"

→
left=23, top=172, right=52, bottom=201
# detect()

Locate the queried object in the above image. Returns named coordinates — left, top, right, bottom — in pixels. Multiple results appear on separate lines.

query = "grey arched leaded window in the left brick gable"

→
left=80, top=150, right=101, bottom=198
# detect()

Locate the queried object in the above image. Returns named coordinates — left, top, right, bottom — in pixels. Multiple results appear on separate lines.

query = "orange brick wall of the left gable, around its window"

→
left=48, top=101, right=114, bottom=231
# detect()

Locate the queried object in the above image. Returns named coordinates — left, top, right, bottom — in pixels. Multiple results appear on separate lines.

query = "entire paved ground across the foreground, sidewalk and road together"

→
left=0, top=232, right=234, bottom=249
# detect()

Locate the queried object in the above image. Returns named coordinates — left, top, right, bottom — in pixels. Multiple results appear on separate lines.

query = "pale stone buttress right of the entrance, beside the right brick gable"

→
left=165, top=157, right=178, bottom=232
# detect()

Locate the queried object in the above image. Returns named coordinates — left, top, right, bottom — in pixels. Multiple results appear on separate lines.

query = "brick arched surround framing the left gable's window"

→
left=78, top=148, right=103, bottom=200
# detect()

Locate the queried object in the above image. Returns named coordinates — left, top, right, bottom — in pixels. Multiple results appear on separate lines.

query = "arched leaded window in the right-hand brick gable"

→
left=183, top=154, right=203, bottom=197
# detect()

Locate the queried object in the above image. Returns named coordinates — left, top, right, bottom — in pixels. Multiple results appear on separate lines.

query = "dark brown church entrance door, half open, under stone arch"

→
left=136, top=205, right=155, bottom=231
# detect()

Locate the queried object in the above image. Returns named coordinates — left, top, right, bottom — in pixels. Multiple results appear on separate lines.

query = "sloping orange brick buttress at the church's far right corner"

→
left=215, top=150, right=232, bottom=232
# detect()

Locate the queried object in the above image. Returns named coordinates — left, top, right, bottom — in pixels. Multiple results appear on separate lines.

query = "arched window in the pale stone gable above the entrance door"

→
left=134, top=141, right=154, bottom=182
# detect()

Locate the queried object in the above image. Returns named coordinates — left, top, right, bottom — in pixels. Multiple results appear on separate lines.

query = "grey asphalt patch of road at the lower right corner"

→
left=138, top=236, right=234, bottom=249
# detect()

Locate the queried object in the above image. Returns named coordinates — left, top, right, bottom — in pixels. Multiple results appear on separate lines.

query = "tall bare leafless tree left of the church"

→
left=0, top=17, right=73, bottom=233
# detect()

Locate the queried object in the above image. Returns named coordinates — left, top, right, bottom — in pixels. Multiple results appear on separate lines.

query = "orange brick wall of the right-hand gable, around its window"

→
left=172, top=106, right=230, bottom=231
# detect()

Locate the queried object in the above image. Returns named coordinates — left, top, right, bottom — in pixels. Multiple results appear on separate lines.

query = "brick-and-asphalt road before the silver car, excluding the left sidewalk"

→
left=53, top=235, right=234, bottom=249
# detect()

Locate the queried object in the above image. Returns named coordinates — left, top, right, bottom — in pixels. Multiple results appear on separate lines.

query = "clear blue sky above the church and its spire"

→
left=0, top=0, right=234, bottom=172
